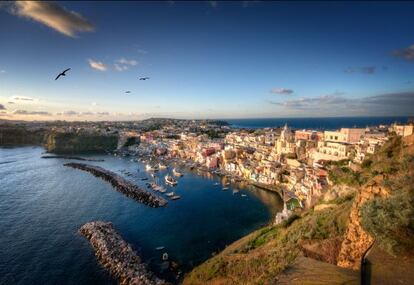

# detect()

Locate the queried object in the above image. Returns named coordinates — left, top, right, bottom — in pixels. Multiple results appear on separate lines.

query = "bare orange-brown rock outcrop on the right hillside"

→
left=337, top=177, right=389, bottom=270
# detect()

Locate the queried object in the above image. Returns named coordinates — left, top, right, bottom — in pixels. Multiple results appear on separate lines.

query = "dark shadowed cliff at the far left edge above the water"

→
left=0, top=126, right=46, bottom=146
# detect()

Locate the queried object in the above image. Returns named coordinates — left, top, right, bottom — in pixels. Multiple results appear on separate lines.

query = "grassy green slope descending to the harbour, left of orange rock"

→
left=184, top=197, right=352, bottom=284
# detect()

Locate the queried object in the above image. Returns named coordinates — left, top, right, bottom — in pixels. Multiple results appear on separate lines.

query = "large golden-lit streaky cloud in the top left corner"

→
left=12, top=1, right=95, bottom=38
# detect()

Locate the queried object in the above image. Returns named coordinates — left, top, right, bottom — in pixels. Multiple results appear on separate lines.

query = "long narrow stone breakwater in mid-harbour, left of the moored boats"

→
left=64, top=163, right=167, bottom=208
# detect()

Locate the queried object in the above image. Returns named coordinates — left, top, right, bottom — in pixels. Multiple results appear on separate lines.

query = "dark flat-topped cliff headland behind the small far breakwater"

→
left=46, top=132, right=118, bottom=154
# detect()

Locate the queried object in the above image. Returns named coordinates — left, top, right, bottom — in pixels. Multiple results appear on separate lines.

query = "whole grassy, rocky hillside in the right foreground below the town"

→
left=184, top=136, right=414, bottom=284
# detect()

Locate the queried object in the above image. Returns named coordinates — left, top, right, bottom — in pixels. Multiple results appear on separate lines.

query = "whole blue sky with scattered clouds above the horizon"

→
left=0, top=1, right=414, bottom=120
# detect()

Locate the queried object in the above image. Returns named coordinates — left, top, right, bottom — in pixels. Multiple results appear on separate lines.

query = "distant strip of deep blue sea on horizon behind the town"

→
left=225, top=117, right=408, bottom=130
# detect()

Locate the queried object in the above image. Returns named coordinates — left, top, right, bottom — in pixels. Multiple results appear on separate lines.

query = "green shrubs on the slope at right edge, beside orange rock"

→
left=361, top=134, right=414, bottom=255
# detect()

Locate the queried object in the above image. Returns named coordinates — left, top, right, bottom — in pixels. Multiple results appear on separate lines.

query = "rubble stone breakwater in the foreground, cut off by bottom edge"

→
left=79, top=221, right=168, bottom=285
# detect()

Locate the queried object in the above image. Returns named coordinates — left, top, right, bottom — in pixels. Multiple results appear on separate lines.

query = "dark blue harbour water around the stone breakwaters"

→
left=0, top=147, right=281, bottom=284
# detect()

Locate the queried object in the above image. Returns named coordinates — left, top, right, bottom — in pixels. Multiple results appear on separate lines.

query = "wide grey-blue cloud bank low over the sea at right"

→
left=270, top=91, right=414, bottom=116
